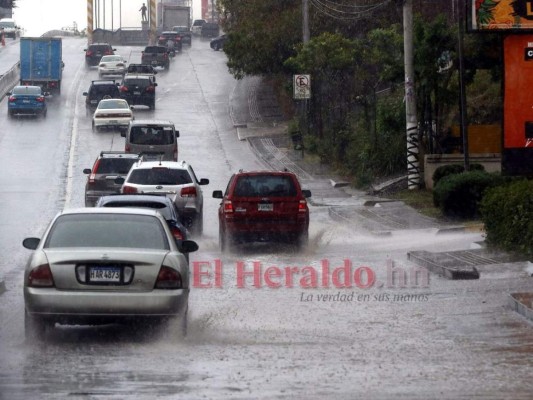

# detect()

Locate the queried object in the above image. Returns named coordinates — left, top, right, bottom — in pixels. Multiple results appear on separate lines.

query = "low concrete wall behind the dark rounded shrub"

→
left=424, top=153, right=502, bottom=189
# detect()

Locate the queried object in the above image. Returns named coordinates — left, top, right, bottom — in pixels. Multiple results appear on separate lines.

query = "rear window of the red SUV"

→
left=233, top=175, right=296, bottom=197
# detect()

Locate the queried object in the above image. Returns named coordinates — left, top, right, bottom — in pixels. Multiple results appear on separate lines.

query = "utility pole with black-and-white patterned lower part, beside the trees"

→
left=403, top=0, right=420, bottom=190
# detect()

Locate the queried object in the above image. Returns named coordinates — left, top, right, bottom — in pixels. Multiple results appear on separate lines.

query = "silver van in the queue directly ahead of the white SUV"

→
left=121, top=119, right=180, bottom=161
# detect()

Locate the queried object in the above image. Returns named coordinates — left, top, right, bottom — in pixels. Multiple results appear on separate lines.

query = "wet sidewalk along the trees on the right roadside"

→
left=234, top=77, right=526, bottom=290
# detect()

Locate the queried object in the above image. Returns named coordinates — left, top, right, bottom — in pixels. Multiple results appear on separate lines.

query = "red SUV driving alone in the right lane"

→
left=213, top=171, right=311, bottom=251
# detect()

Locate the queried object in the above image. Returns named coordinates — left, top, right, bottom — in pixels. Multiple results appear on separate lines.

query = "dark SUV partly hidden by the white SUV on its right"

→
left=83, top=151, right=140, bottom=207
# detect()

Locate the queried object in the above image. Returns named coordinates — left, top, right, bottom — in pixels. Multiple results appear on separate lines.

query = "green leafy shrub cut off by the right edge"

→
left=480, top=180, right=533, bottom=255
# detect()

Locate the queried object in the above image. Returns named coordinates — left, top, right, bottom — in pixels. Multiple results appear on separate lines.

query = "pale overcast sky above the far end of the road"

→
left=13, top=0, right=200, bottom=36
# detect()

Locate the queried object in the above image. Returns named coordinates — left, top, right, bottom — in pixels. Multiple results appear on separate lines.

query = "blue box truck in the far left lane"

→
left=20, top=37, right=63, bottom=94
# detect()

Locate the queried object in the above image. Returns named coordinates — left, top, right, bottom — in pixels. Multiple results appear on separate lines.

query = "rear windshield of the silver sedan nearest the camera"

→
left=44, top=213, right=170, bottom=250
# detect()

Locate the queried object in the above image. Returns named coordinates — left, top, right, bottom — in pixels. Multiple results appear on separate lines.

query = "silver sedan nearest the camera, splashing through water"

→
left=22, top=207, right=198, bottom=340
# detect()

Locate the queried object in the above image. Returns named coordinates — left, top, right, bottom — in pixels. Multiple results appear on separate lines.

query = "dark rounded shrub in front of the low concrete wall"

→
left=433, top=171, right=503, bottom=218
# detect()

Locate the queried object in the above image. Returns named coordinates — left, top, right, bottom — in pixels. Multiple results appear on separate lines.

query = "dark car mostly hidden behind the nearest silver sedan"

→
left=95, top=194, right=189, bottom=240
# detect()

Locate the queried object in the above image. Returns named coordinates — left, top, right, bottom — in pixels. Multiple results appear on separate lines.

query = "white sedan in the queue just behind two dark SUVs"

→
left=92, top=99, right=134, bottom=132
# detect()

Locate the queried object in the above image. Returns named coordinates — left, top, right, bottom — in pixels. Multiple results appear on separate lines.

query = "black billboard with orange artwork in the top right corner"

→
left=467, top=0, right=533, bottom=31
